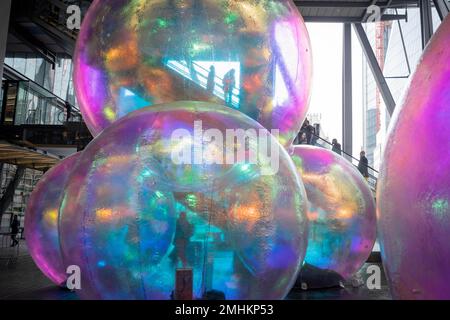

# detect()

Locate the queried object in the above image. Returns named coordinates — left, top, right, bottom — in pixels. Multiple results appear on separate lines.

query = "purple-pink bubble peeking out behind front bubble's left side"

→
left=24, top=153, right=80, bottom=286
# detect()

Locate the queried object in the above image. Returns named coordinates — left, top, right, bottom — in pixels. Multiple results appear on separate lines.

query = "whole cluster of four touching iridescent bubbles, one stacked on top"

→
left=22, top=0, right=410, bottom=299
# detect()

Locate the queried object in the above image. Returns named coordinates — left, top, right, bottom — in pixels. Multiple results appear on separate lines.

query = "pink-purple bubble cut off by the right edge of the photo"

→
left=377, top=16, right=450, bottom=299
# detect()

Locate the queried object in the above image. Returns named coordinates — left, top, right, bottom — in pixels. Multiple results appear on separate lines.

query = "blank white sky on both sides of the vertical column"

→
left=306, top=23, right=363, bottom=158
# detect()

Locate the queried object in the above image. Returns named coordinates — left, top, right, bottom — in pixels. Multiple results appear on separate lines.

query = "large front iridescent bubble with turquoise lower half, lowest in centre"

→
left=61, top=102, right=307, bottom=299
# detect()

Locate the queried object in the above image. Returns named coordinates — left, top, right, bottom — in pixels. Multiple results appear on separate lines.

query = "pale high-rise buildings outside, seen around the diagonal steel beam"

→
left=362, top=8, right=441, bottom=170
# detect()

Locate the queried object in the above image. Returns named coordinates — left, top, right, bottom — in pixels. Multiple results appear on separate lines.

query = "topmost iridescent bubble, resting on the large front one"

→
left=74, top=0, right=312, bottom=146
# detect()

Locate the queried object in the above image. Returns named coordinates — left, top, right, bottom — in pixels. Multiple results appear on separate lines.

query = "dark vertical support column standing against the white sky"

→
left=342, top=23, right=353, bottom=161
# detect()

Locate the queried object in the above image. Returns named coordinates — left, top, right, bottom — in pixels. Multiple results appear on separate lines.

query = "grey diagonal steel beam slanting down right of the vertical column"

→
left=353, top=23, right=395, bottom=116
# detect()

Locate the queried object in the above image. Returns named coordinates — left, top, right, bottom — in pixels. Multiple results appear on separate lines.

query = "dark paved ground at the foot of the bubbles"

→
left=0, top=241, right=391, bottom=300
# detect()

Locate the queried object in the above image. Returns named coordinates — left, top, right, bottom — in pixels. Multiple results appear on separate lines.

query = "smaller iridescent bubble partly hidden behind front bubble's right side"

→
left=290, top=146, right=376, bottom=279
